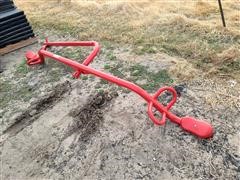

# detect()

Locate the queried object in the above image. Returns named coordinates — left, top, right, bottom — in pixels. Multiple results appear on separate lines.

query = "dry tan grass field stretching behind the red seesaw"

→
left=16, top=0, right=240, bottom=78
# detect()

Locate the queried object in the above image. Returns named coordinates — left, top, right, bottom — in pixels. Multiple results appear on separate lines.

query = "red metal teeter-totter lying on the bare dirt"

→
left=26, top=39, right=213, bottom=138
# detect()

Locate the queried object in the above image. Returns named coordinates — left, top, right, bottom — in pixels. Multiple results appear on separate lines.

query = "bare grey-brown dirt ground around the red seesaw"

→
left=0, top=32, right=240, bottom=179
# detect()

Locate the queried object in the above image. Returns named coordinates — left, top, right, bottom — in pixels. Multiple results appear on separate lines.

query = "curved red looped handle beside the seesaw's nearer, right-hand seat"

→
left=148, top=87, right=177, bottom=125
